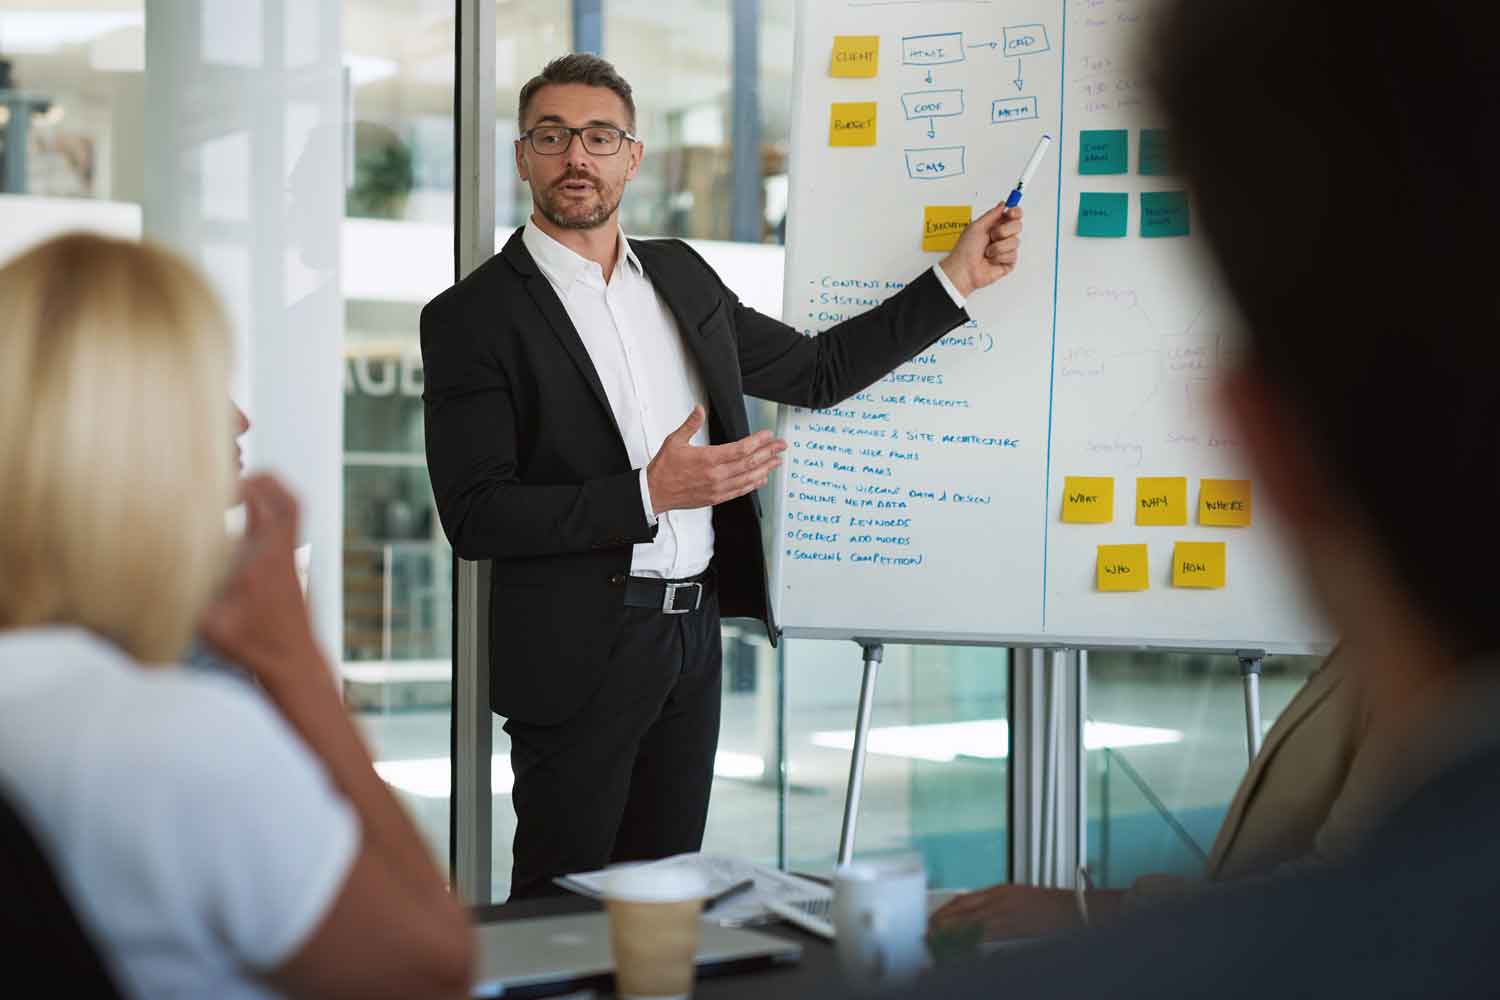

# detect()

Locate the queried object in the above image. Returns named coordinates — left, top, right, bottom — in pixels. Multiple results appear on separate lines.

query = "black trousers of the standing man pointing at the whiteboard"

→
left=506, top=589, right=723, bottom=900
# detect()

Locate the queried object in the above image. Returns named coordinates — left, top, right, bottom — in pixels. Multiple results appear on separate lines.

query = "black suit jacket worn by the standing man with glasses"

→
left=422, top=229, right=968, bottom=724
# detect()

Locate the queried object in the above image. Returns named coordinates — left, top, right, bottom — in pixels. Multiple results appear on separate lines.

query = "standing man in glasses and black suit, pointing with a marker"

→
left=422, top=55, right=1022, bottom=898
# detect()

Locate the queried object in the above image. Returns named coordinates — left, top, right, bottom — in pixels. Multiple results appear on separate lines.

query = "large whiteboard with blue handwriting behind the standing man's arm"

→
left=773, top=0, right=1334, bottom=652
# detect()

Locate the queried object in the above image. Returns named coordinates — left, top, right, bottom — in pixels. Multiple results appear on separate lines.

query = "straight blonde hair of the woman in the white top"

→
left=0, top=234, right=234, bottom=663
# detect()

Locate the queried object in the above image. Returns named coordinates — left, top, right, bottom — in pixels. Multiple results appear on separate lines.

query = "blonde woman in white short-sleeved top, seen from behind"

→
left=0, top=235, right=470, bottom=997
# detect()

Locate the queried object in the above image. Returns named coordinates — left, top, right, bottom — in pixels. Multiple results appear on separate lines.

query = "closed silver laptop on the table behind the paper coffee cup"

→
left=473, top=913, right=803, bottom=997
